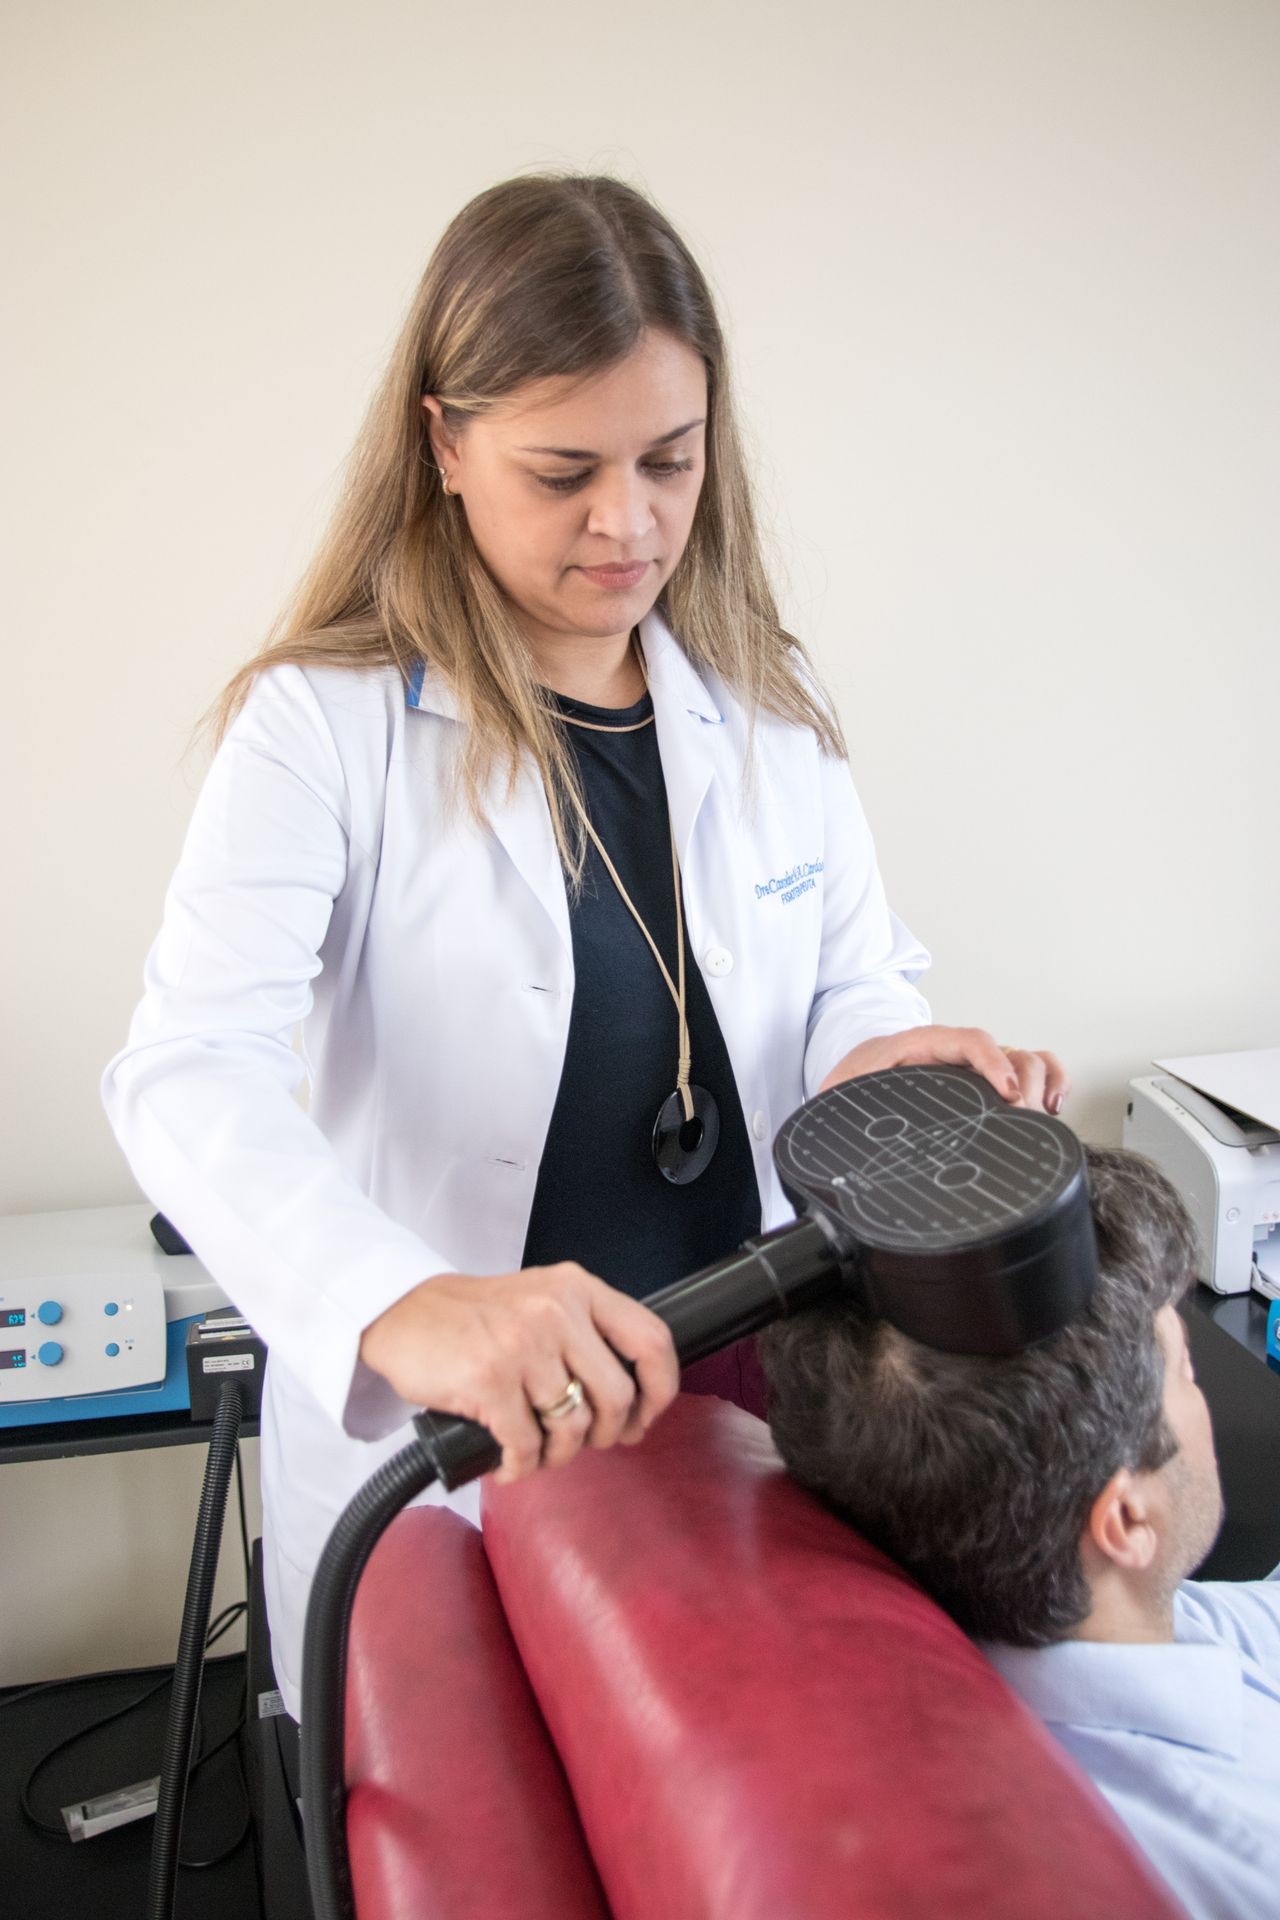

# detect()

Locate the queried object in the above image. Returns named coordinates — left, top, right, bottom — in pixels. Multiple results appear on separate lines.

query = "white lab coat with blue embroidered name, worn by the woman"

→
left=104, top=611, right=929, bottom=1715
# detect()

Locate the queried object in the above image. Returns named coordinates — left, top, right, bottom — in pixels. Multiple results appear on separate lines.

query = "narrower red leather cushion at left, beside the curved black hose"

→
left=345, top=1507, right=608, bottom=1920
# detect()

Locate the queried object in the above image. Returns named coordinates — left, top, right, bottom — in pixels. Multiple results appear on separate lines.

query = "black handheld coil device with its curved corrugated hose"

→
left=301, top=1068, right=1096, bottom=1920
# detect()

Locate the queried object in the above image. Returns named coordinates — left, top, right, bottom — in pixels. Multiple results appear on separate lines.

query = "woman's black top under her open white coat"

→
left=522, top=693, right=760, bottom=1296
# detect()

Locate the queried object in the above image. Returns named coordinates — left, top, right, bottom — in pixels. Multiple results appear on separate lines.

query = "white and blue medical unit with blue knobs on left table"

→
left=0, top=1206, right=226, bottom=1428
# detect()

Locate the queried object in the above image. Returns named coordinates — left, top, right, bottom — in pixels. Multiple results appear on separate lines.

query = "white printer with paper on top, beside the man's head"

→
left=1125, top=1064, right=1280, bottom=1300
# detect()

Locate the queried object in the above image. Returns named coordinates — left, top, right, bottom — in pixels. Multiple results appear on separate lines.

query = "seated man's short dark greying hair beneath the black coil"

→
left=760, top=1148, right=1196, bottom=1645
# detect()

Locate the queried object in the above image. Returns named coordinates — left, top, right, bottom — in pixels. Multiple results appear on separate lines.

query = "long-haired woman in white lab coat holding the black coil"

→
left=104, top=177, right=1065, bottom=1715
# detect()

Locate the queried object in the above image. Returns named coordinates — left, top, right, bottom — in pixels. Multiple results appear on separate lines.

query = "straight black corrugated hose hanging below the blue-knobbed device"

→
left=146, top=1380, right=242, bottom=1920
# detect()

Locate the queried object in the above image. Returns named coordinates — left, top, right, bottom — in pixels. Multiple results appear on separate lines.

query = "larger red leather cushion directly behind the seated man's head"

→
left=485, top=1398, right=1178, bottom=1920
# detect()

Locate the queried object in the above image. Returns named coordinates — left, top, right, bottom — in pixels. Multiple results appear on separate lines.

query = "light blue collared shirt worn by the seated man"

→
left=983, top=1567, right=1280, bottom=1920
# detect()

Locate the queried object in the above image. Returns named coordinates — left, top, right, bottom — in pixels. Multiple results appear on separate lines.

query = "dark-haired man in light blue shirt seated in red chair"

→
left=760, top=1150, right=1280, bottom=1920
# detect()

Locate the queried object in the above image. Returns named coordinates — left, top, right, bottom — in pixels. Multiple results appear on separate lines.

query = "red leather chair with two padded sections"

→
left=347, top=1396, right=1180, bottom=1920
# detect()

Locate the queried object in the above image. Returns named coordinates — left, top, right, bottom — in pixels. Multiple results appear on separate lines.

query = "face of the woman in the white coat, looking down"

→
left=422, top=332, right=706, bottom=675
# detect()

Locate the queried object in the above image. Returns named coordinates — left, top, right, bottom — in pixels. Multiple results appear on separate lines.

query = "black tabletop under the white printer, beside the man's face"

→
left=1182, top=1284, right=1280, bottom=1580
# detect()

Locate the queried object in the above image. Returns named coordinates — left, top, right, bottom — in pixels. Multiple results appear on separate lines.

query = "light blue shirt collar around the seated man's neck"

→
left=983, top=1620, right=1244, bottom=1761
